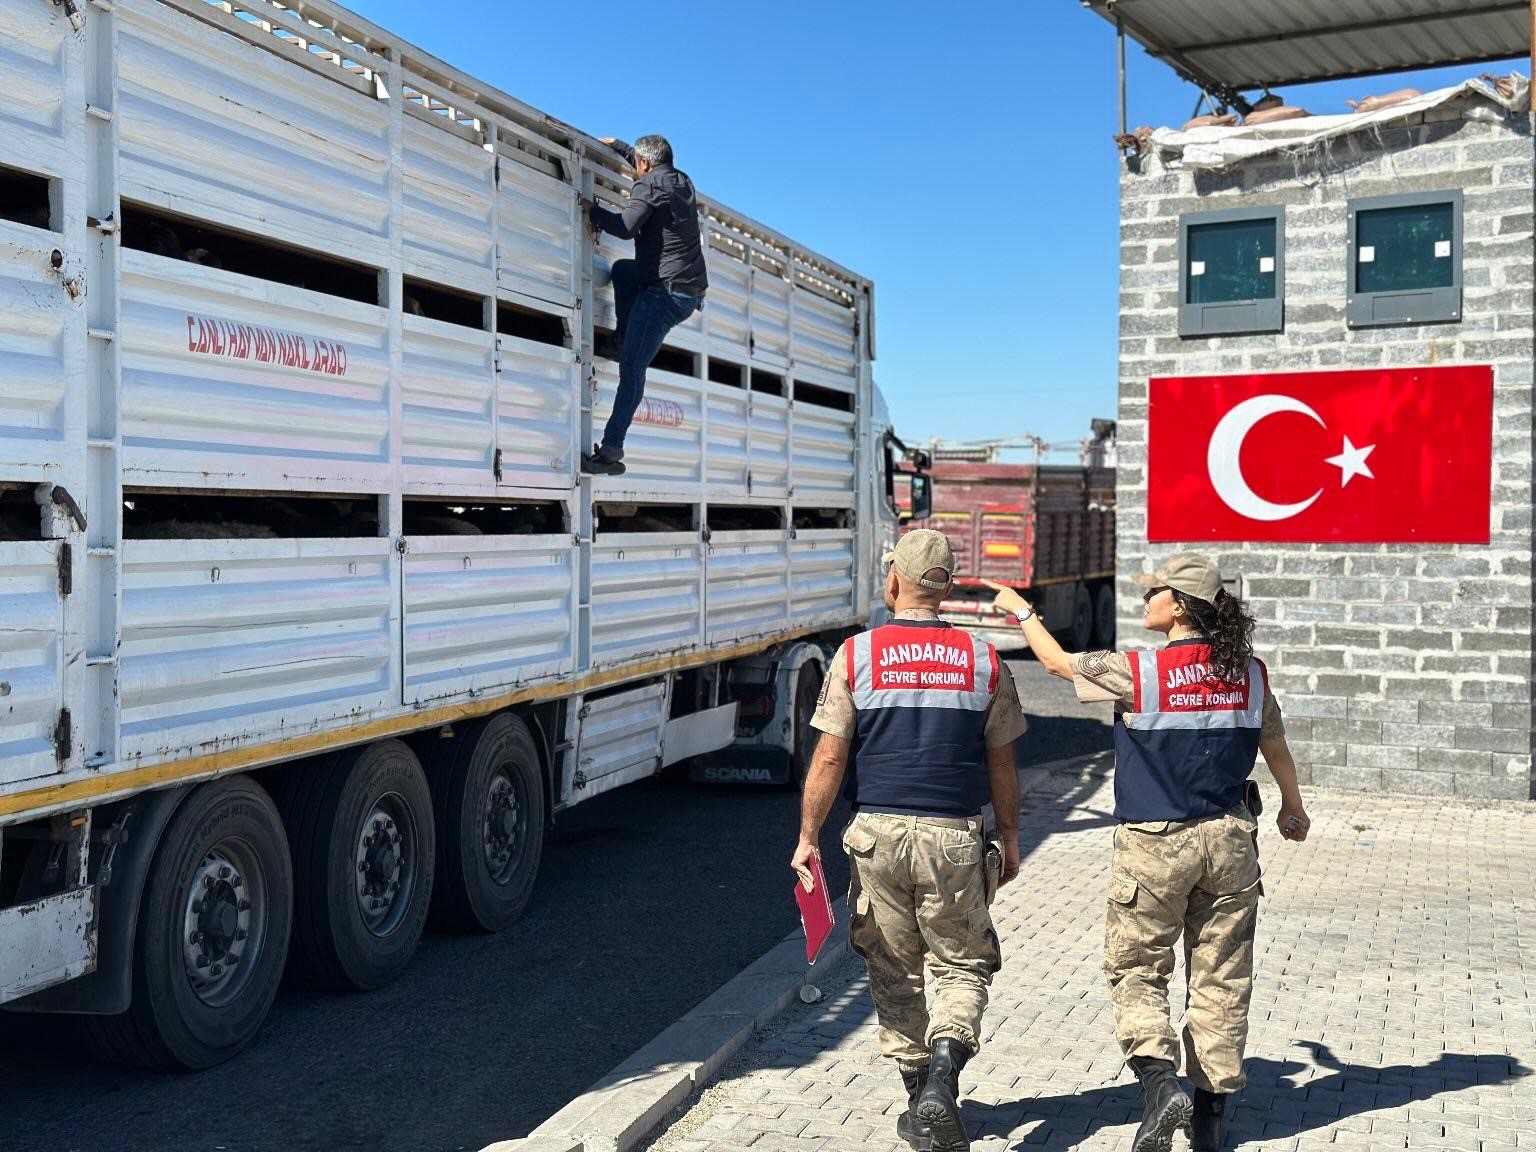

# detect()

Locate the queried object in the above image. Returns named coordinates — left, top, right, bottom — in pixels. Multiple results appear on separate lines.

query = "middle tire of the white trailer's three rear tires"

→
left=278, top=740, right=436, bottom=992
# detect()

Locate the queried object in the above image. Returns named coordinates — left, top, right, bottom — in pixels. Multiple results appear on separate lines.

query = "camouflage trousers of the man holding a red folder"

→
left=843, top=813, right=1003, bottom=1069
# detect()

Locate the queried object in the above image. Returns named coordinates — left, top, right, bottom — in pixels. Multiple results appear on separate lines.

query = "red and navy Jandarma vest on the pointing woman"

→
left=1115, top=641, right=1269, bottom=822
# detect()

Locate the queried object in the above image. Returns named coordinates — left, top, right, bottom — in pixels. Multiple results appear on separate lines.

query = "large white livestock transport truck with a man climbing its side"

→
left=0, top=0, right=922, bottom=1069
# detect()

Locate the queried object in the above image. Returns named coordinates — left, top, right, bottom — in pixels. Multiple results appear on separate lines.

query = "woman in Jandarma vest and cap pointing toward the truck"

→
left=992, top=554, right=1309, bottom=1152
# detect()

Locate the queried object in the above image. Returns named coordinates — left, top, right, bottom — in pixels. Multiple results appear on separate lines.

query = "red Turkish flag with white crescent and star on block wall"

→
left=1147, top=366, right=1493, bottom=544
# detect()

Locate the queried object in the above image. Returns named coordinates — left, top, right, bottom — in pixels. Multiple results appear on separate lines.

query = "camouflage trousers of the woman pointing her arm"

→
left=1104, top=808, right=1263, bottom=1092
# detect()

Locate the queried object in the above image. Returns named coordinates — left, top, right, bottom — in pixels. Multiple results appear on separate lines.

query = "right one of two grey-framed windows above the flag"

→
left=1346, top=190, right=1461, bottom=327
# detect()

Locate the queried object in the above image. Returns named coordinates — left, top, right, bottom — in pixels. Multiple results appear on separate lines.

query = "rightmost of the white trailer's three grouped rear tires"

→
left=427, top=713, right=545, bottom=932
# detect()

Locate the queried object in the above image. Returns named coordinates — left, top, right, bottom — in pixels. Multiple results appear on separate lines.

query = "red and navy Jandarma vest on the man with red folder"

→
left=843, top=621, right=998, bottom=816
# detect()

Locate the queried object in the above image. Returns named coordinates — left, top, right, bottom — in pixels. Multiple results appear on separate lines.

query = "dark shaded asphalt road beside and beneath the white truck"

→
left=0, top=660, right=1111, bottom=1152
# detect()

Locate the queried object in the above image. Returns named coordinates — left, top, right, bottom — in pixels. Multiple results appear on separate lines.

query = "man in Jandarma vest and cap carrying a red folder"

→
left=791, top=528, right=1026, bottom=1152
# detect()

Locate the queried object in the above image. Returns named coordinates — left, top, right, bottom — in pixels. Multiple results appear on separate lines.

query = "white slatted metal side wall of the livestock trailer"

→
left=0, top=0, right=872, bottom=804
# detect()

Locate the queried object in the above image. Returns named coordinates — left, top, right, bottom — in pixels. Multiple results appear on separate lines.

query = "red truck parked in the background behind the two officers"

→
left=903, top=421, right=1115, bottom=651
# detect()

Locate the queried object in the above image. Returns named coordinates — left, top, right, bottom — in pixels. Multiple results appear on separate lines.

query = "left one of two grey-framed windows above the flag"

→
left=1178, top=207, right=1286, bottom=336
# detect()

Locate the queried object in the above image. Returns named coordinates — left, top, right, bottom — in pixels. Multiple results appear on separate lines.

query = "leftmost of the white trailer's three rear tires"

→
left=84, top=776, right=293, bottom=1071
